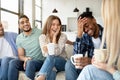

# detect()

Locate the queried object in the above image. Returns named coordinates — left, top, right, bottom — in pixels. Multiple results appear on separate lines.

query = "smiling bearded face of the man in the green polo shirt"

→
left=19, top=17, right=31, bottom=32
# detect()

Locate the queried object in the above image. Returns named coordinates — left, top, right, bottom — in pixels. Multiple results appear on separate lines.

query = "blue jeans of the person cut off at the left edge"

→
left=0, top=57, right=14, bottom=80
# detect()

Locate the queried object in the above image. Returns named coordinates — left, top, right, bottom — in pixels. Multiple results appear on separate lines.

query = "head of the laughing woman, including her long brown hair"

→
left=42, top=15, right=61, bottom=42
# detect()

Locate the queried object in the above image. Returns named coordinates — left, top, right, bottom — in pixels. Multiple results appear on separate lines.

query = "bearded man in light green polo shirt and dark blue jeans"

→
left=8, top=15, right=45, bottom=80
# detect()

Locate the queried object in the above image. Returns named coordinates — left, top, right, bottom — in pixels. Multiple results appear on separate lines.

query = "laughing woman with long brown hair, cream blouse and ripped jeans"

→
left=37, top=15, right=67, bottom=80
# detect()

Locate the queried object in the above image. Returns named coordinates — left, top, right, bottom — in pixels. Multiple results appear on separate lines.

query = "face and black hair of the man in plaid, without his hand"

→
left=78, top=12, right=99, bottom=38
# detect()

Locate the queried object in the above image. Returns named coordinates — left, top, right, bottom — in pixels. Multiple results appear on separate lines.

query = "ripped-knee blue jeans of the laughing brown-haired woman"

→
left=38, top=55, right=66, bottom=80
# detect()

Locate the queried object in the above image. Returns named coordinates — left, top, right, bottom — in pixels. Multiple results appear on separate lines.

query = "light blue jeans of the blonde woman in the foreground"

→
left=77, top=65, right=114, bottom=80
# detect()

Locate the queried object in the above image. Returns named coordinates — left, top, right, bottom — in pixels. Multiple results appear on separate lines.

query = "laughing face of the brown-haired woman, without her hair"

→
left=50, top=19, right=61, bottom=35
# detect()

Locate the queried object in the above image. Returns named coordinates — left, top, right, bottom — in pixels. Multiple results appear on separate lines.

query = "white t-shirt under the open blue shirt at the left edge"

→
left=0, top=37, right=15, bottom=58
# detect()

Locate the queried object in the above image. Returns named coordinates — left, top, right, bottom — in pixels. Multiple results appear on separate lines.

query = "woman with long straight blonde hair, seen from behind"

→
left=77, top=0, right=120, bottom=80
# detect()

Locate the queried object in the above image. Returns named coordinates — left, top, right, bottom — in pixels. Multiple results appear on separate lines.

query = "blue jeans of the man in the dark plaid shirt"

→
left=65, top=60, right=82, bottom=80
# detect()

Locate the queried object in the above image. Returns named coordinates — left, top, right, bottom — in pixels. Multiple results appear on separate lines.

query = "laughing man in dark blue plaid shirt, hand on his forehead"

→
left=65, top=12, right=100, bottom=80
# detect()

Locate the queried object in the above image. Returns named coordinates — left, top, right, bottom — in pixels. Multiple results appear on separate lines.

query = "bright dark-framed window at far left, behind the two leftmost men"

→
left=0, top=0, right=23, bottom=33
